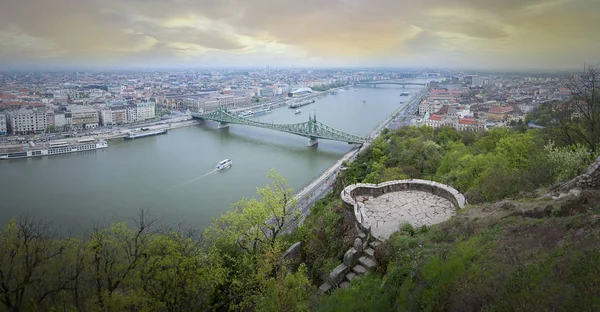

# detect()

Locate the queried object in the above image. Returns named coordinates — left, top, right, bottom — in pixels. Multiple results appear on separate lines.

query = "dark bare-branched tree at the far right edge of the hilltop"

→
left=553, top=65, right=600, bottom=152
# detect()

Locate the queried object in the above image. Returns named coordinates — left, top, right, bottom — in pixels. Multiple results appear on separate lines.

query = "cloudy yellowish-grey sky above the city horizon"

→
left=0, top=0, right=600, bottom=69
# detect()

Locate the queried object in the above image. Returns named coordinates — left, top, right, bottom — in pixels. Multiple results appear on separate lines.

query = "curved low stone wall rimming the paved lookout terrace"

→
left=340, top=179, right=467, bottom=233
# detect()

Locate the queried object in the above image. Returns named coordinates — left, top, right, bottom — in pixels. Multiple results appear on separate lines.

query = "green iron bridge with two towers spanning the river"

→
left=192, top=106, right=368, bottom=146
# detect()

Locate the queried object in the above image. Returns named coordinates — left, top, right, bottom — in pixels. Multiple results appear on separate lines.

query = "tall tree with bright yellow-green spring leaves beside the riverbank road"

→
left=204, top=170, right=299, bottom=310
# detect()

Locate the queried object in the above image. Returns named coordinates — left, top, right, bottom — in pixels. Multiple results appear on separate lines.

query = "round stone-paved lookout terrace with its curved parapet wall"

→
left=341, top=179, right=466, bottom=240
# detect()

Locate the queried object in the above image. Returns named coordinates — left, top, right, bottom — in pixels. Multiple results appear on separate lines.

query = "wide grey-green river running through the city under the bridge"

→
left=0, top=86, right=422, bottom=231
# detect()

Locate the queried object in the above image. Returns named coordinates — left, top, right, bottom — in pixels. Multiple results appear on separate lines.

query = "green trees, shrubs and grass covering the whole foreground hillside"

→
left=0, top=67, right=600, bottom=311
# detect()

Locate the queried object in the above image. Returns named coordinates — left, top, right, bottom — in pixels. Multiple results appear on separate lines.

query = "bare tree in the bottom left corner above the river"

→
left=0, top=215, right=82, bottom=311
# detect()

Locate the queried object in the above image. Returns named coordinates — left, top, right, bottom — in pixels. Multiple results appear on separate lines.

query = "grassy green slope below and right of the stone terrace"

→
left=319, top=190, right=600, bottom=311
